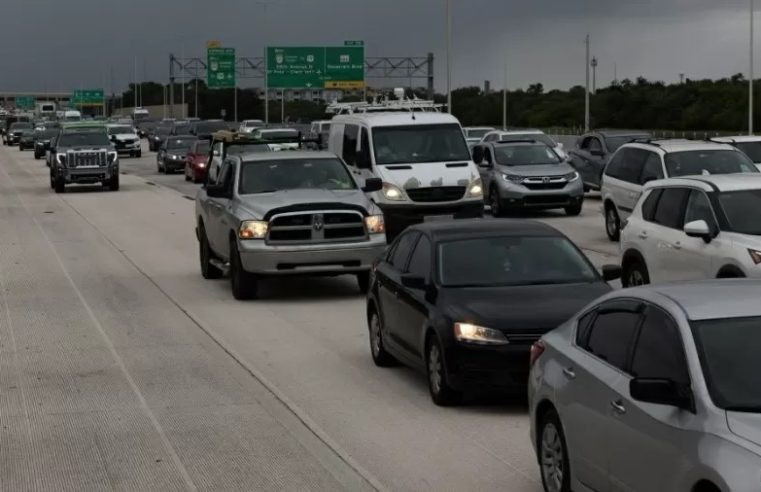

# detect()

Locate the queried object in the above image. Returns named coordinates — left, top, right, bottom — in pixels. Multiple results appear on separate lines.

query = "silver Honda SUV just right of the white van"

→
left=473, top=139, right=584, bottom=217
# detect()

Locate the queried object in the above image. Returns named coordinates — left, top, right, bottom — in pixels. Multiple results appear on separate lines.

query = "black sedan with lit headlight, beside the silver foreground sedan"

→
left=367, top=219, right=621, bottom=405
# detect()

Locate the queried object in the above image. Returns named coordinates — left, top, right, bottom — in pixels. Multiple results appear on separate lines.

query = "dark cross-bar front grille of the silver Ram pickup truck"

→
left=267, top=210, right=367, bottom=244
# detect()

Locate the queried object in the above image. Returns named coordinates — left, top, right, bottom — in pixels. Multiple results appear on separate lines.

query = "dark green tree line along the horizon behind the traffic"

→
left=114, top=74, right=761, bottom=132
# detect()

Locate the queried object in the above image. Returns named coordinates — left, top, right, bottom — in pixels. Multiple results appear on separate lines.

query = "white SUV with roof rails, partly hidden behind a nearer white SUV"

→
left=600, top=139, right=759, bottom=241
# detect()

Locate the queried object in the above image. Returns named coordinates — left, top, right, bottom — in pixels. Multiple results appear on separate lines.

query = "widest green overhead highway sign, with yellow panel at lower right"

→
left=267, top=45, right=365, bottom=89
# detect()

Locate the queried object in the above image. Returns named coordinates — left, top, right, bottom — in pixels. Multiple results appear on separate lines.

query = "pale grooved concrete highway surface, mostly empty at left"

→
left=0, top=139, right=616, bottom=492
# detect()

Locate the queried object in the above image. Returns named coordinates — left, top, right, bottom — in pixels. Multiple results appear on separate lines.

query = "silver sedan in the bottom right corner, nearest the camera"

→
left=529, top=280, right=761, bottom=492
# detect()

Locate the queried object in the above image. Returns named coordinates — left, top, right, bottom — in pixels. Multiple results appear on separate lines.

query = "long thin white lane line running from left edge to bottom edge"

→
left=0, top=156, right=198, bottom=491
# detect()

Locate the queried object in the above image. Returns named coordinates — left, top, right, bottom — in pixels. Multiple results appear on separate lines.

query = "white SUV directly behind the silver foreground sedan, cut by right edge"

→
left=621, top=173, right=761, bottom=287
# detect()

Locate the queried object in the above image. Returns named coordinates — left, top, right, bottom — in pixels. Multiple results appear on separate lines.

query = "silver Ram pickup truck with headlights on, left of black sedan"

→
left=196, top=151, right=386, bottom=299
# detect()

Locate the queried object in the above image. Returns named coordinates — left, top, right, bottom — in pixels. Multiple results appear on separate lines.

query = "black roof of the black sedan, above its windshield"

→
left=409, top=219, right=565, bottom=241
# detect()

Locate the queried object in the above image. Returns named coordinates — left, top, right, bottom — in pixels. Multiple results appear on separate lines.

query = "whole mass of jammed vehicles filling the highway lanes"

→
left=0, top=96, right=761, bottom=492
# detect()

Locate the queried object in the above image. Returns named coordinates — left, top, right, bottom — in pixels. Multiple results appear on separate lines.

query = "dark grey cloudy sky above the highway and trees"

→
left=0, top=0, right=761, bottom=91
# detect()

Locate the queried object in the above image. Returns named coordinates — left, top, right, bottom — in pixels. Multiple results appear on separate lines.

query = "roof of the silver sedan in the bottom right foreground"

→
left=613, top=279, right=761, bottom=321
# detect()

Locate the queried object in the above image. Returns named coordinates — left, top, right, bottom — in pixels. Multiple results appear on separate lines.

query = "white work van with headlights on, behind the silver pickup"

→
left=328, top=111, right=484, bottom=239
